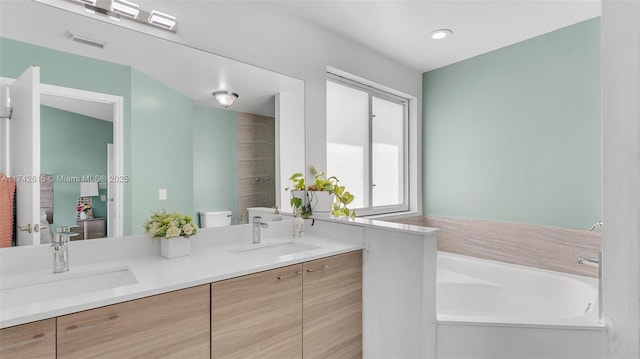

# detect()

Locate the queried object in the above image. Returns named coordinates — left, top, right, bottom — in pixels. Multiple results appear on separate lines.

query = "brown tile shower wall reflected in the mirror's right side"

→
left=238, top=112, right=276, bottom=221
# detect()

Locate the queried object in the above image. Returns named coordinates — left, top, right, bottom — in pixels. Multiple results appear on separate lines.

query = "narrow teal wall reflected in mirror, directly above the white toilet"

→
left=193, top=106, right=238, bottom=223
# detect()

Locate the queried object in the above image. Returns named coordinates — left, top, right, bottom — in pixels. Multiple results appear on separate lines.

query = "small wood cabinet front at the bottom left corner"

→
left=0, top=318, right=56, bottom=359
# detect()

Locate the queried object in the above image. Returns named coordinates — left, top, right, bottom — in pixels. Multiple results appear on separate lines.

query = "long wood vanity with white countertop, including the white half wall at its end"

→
left=0, top=220, right=435, bottom=358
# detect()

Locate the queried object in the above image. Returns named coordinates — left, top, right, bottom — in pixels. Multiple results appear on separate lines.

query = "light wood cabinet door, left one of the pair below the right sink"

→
left=211, top=264, right=302, bottom=359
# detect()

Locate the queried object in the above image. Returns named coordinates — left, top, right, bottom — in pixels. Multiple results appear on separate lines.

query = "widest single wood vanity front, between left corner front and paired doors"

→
left=57, top=284, right=211, bottom=359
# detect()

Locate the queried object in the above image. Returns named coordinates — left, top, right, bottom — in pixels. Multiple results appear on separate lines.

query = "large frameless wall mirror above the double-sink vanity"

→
left=0, top=1, right=305, bottom=246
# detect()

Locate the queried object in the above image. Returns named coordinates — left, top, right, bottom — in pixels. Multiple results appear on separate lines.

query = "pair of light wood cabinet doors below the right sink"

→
left=211, top=251, right=362, bottom=359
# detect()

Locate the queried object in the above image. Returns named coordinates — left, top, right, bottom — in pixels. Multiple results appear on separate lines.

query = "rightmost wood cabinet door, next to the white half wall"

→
left=302, top=251, right=362, bottom=359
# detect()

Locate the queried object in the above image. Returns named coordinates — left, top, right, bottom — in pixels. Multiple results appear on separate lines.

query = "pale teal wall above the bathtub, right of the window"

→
left=423, top=18, right=602, bottom=228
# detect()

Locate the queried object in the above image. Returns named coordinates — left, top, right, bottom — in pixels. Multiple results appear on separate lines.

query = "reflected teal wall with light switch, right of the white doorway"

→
left=131, top=70, right=193, bottom=234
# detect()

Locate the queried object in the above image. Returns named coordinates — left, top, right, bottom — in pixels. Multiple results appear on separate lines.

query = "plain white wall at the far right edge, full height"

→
left=602, top=0, right=640, bottom=358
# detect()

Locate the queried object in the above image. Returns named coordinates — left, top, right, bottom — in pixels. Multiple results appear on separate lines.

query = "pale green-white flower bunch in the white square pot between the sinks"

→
left=144, top=209, right=198, bottom=239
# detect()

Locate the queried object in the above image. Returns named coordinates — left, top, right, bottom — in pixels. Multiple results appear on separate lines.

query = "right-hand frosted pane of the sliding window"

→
left=372, top=97, right=404, bottom=207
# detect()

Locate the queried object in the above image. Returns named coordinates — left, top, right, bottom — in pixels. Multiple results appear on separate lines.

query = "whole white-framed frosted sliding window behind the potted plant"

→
left=327, top=74, right=409, bottom=215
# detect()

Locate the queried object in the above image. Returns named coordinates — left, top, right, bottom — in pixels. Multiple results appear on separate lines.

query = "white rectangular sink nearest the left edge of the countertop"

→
left=0, top=263, right=138, bottom=307
